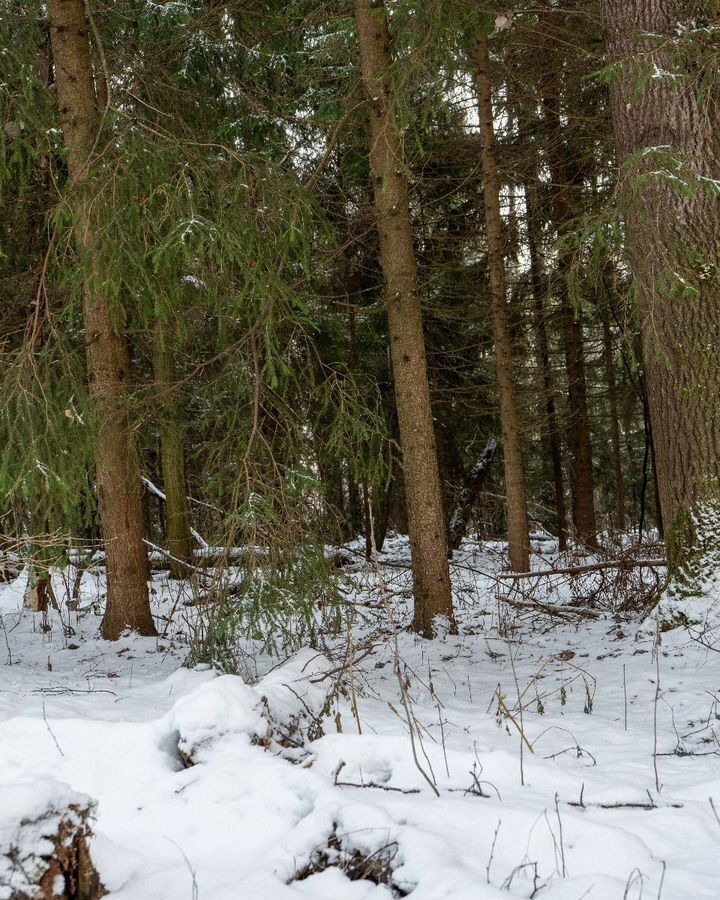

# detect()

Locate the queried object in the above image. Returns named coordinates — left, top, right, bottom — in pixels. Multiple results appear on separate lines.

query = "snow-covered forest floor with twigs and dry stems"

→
left=0, top=539, right=720, bottom=900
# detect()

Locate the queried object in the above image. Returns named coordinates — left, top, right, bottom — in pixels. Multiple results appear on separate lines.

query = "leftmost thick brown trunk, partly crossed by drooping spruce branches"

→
left=47, top=0, right=155, bottom=639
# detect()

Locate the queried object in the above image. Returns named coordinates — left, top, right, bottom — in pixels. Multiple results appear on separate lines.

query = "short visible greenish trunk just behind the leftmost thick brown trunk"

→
left=153, top=318, right=193, bottom=578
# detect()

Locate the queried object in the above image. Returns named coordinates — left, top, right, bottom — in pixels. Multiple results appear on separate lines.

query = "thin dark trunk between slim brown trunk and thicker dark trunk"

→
left=525, top=181, right=568, bottom=550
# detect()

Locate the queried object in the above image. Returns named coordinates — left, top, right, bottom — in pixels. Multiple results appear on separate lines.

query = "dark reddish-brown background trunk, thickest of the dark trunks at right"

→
left=543, top=53, right=597, bottom=549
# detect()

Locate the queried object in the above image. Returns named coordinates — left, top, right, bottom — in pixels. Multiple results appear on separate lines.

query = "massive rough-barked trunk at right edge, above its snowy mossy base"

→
left=601, top=0, right=720, bottom=557
